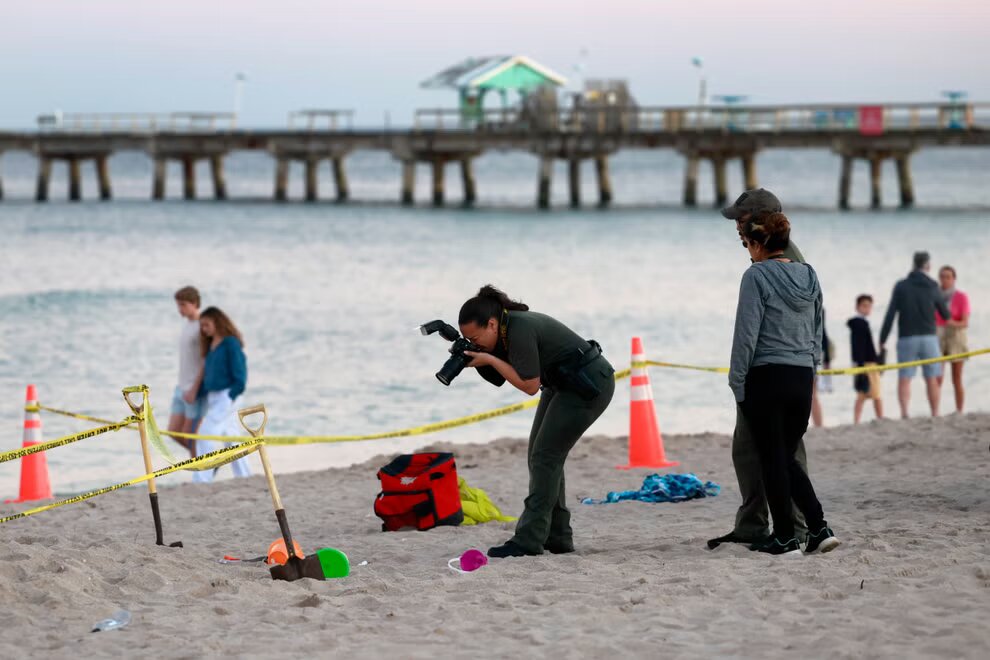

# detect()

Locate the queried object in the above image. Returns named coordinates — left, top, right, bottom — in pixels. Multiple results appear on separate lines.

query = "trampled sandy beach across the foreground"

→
left=0, top=414, right=990, bottom=658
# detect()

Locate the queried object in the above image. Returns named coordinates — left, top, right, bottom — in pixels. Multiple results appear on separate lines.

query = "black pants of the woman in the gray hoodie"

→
left=742, top=364, right=825, bottom=541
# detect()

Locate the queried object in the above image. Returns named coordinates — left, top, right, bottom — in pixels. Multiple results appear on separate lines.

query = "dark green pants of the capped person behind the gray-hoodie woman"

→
left=732, top=405, right=808, bottom=542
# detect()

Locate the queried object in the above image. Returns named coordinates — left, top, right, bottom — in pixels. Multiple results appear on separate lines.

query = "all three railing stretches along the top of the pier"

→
left=31, top=103, right=990, bottom=134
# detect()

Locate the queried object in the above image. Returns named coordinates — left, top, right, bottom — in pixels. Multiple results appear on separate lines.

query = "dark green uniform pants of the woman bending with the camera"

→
left=512, top=357, right=615, bottom=554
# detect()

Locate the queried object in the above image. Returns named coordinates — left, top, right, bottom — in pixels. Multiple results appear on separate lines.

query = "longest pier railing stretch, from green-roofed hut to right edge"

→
left=413, top=103, right=990, bottom=133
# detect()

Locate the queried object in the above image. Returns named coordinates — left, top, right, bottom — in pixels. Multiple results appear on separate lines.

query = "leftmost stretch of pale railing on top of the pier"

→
left=38, top=112, right=237, bottom=133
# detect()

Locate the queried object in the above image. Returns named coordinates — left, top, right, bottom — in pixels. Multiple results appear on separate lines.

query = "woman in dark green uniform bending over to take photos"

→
left=457, top=286, right=615, bottom=557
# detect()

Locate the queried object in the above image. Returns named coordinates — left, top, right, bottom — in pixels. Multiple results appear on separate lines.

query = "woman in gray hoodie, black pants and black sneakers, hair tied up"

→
left=729, top=213, right=839, bottom=555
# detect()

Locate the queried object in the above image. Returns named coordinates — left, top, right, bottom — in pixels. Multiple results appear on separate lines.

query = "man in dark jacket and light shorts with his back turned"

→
left=880, top=252, right=952, bottom=419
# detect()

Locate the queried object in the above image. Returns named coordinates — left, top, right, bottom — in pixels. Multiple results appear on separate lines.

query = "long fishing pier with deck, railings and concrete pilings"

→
left=0, top=103, right=990, bottom=208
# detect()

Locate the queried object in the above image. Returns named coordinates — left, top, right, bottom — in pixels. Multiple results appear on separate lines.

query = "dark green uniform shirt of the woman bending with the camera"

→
left=478, top=312, right=588, bottom=387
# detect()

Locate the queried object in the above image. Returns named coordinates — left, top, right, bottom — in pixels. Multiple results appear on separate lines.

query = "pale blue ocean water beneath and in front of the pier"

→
left=0, top=150, right=990, bottom=496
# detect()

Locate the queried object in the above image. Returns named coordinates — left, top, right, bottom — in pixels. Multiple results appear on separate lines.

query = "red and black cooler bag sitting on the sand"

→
left=375, top=453, right=464, bottom=532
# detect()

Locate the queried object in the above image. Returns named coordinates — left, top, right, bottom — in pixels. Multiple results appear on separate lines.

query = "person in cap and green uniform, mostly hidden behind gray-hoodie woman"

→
left=708, top=188, right=808, bottom=550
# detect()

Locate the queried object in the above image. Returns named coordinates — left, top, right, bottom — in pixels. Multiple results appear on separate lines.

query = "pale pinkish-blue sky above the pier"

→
left=0, top=0, right=990, bottom=128
